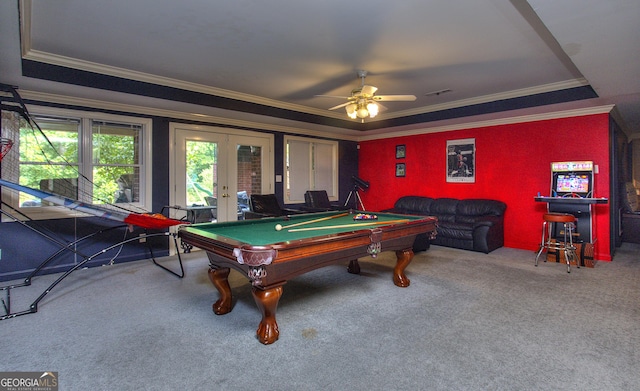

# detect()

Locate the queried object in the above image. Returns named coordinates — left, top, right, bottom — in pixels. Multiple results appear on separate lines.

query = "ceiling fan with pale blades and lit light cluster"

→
left=316, top=70, right=416, bottom=122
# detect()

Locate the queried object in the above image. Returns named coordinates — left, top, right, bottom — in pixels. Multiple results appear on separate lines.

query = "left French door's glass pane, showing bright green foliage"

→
left=186, top=140, right=218, bottom=222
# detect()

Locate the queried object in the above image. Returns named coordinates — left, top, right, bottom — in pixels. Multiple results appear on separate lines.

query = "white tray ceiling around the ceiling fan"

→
left=0, top=0, right=640, bottom=137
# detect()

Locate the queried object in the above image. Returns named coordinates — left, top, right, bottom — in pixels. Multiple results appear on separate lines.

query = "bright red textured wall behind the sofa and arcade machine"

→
left=359, top=114, right=611, bottom=261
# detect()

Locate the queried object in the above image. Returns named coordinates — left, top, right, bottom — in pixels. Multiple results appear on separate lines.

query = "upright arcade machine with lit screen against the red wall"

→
left=535, top=161, right=608, bottom=266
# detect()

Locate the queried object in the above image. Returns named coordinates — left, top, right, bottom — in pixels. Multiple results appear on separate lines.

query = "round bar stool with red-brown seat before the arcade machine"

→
left=535, top=212, right=580, bottom=273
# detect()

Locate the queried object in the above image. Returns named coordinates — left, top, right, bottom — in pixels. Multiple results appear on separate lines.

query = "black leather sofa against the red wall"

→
left=387, top=196, right=507, bottom=253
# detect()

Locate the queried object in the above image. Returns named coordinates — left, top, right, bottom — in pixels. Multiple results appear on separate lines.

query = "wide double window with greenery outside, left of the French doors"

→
left=2, top=108, right=151, bottom=219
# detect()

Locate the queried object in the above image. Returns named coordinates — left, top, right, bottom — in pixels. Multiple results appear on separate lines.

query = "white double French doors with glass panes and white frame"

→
left=169, top=124, right=274, bottom=222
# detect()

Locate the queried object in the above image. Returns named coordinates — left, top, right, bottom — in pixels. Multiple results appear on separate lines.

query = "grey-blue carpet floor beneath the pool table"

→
left=0, top=243, right=640, bottom=391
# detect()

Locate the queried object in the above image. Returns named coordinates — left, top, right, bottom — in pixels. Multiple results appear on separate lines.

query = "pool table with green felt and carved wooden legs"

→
left=178, top=211, right=437, bottom=344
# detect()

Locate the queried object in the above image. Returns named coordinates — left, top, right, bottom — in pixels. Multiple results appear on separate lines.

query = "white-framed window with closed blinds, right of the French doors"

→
left=284, top=136, right=338, bottom=203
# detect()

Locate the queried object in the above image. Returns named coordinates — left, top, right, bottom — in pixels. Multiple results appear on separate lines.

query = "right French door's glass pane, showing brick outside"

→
left=237, top=145, right=262, bottom=220
